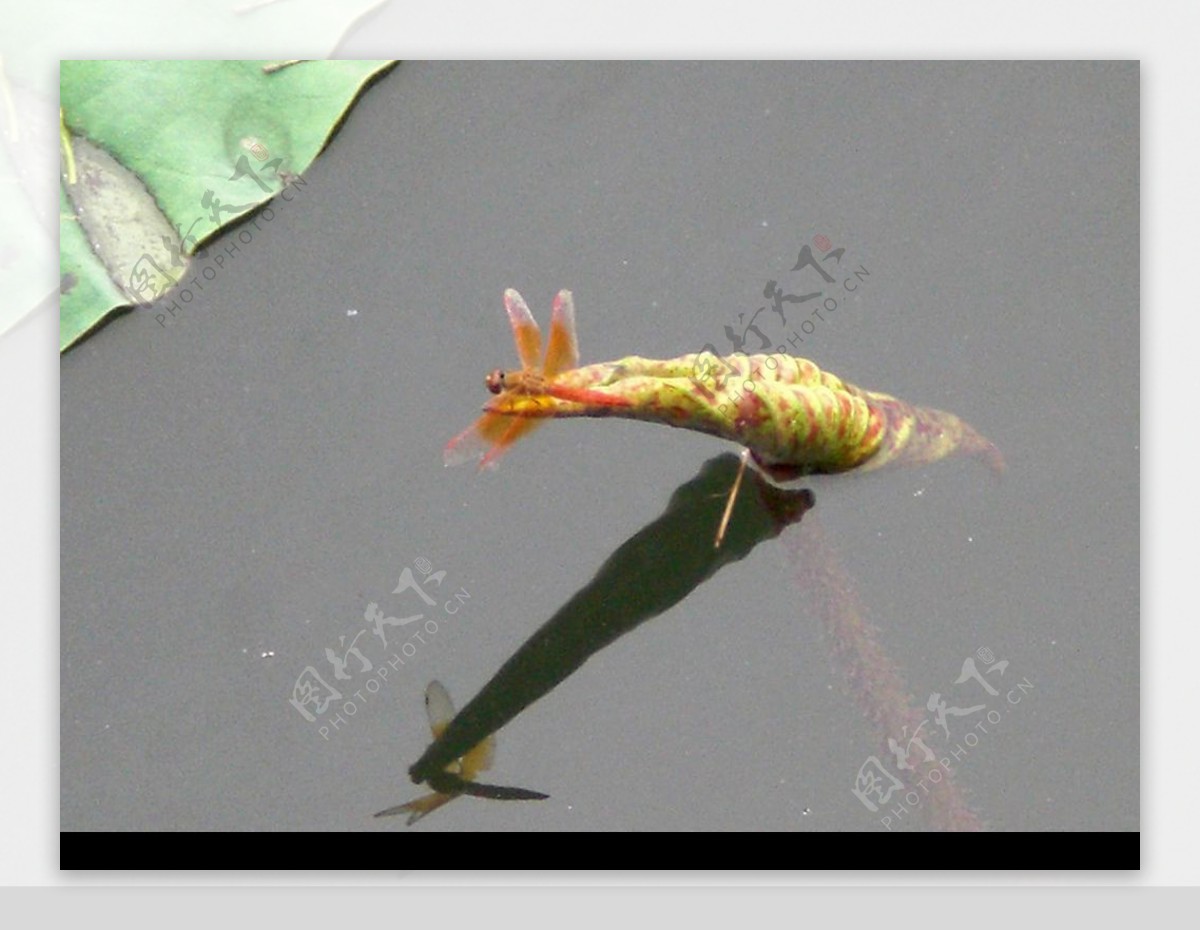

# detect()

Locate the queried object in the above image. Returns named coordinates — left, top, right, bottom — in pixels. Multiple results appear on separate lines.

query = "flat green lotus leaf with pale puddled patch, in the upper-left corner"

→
left=59, top=61, right=391, bottom=350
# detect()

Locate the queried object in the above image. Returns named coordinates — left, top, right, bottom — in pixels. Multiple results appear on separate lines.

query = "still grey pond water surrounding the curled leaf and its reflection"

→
left=61, top=62, right=1139, bottom=832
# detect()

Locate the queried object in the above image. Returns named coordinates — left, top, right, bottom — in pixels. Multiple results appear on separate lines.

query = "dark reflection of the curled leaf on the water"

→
left=408, top=455, right=814, bottom=793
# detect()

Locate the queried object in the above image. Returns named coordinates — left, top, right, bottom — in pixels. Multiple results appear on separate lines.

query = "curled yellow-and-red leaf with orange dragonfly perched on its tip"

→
left=444, top=288, right=1004, bottom=546
